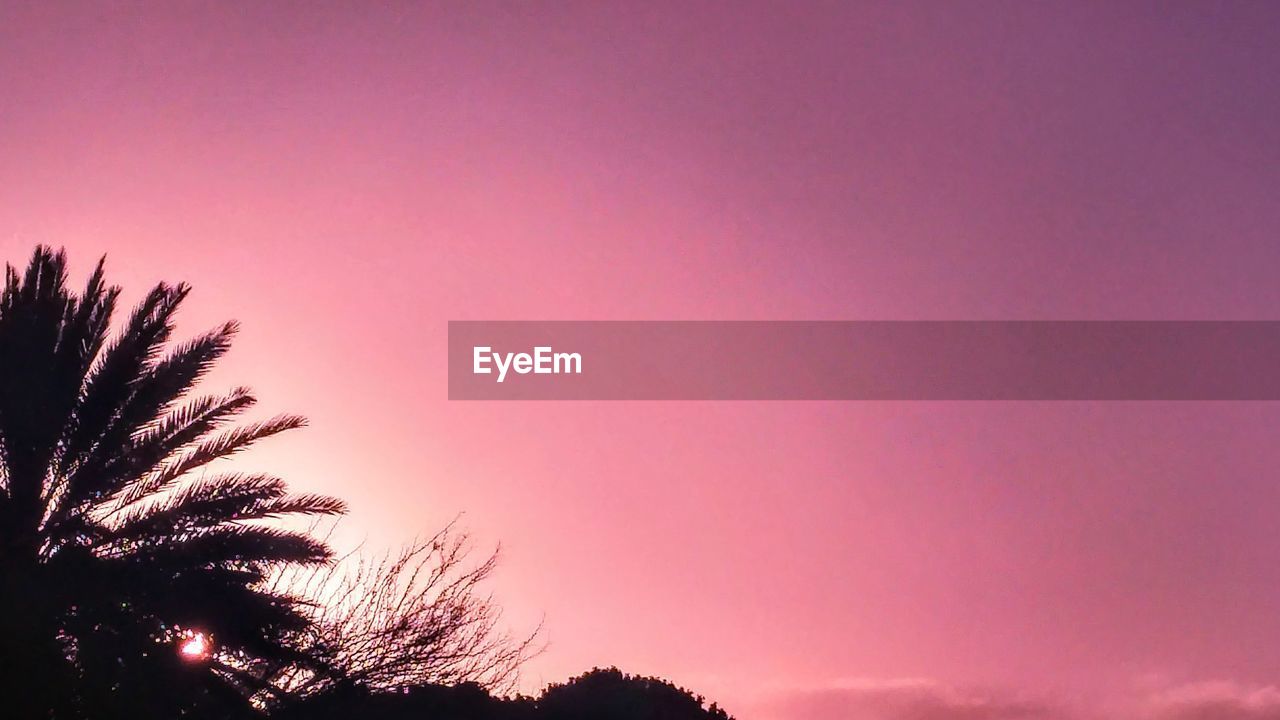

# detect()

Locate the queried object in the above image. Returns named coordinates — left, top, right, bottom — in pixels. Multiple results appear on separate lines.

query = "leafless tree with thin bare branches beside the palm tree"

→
left=264, top=520, right=540, bottom=700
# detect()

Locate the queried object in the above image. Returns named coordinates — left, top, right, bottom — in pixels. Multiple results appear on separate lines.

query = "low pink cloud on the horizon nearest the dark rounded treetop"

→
left=762, top=679, right=1070, bottom=720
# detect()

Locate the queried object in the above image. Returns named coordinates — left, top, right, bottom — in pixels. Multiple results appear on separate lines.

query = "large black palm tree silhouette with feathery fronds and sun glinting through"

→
left=0, top=247, right=344, bottom=720
